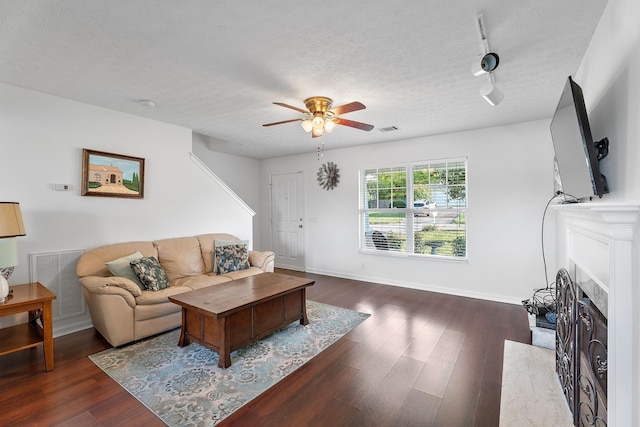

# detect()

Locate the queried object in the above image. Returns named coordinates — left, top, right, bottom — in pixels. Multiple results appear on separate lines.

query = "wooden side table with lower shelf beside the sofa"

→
left=0, top=282, right=56, bottom=372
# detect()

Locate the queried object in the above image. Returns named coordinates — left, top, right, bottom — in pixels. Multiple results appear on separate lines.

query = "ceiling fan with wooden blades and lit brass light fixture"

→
left=262, top=96, right=373, bottom=138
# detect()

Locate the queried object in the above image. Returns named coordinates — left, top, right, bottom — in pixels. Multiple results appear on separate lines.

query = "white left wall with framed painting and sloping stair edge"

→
left=0, top=84, right=252, bottom=334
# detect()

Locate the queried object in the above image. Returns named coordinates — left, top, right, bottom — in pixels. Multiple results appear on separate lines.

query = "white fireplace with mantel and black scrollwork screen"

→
left=553, top=203, right=640, bottom=426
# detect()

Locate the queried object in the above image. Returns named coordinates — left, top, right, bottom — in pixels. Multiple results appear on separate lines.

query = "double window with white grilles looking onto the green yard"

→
left=360, top=158, right=467, bottom=259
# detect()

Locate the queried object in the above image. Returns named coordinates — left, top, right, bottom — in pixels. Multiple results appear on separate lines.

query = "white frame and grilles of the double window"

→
left=358, top=156, right=469, bottom=261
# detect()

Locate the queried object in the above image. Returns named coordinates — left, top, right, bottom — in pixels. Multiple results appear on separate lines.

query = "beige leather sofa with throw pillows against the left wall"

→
left=76, top=234, right=274, bottom=346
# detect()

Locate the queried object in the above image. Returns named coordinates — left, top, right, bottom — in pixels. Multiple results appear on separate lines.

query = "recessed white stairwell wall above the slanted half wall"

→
left=193, top=132, right=262, bottom=250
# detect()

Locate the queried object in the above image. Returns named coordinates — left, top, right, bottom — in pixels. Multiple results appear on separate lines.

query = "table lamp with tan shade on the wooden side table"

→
left=0, top=202, right=26, bottom=303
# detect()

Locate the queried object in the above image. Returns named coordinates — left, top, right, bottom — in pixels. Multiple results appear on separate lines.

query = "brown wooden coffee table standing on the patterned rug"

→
left=169, top=273, right=315, bottom=368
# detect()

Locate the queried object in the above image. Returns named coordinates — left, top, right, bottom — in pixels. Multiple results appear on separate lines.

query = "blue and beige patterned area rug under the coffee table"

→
left=89, top=301, right=370, bottom=426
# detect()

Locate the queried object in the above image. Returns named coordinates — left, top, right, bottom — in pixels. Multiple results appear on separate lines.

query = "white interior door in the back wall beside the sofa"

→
left=271, top=172, right=305, bottom=271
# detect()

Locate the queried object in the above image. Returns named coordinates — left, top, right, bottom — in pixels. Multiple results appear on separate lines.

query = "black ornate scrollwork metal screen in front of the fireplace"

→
left=556, top=268, right=607, bottom=427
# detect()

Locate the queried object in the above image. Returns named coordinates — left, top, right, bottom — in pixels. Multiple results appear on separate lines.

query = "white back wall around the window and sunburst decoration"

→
left=260, top=118, right=553, bottom=303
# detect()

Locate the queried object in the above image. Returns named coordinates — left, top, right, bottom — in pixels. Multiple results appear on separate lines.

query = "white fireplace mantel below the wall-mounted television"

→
left=553, top=203, right=640, bottom=426
